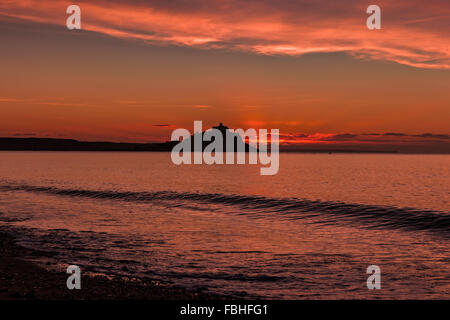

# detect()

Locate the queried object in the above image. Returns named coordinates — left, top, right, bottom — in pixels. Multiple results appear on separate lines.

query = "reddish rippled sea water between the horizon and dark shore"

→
left=0, top=152, right=450, bottom=299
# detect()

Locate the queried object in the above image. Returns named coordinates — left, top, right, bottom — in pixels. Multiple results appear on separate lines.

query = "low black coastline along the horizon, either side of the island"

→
left=0, top=137, right=399, bottom=153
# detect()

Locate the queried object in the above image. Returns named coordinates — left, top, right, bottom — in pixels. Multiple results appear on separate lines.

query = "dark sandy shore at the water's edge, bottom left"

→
left=0, top=230, right=223, bottom=300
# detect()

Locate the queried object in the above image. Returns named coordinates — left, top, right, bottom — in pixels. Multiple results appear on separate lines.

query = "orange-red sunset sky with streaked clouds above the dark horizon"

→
left=0, top=0, right=450, bottom=152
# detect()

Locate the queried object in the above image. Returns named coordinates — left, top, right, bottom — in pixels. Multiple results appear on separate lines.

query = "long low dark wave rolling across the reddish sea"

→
left=0, top=185, right=450, bottom=236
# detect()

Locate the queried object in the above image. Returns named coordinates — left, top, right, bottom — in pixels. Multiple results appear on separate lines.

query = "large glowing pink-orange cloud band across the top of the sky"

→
left=0, top=0, right=450, bottom=69
